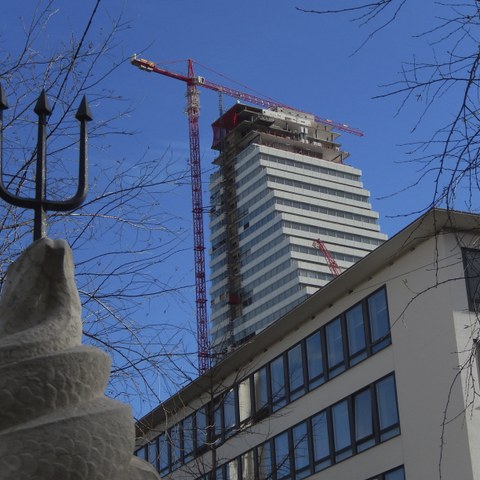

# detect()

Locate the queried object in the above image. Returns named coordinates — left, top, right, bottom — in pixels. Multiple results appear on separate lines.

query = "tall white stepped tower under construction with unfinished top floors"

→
left=210, top=104, right=386, bottom=352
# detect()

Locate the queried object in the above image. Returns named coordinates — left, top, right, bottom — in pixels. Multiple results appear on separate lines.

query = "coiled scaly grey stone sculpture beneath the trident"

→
left=0, top=239, right=160, bottom=480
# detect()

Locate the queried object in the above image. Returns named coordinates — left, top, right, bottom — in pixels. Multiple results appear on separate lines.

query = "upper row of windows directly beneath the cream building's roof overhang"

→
left=137, top=288, right=390, bottom=473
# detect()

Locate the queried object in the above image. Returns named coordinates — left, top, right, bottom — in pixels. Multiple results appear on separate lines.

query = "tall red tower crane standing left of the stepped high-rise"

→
left=131, top=55, right=363, bottom=374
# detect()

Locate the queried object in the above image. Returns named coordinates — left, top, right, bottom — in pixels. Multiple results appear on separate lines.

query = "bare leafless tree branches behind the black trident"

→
left=0, top=0, right=199, bottom=414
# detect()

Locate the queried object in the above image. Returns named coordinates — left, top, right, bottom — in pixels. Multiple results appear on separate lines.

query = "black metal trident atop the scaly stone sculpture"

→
left=0, top=85, right=92, bottom=241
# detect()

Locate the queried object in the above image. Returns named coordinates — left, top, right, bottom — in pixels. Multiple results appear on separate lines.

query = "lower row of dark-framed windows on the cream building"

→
left=199, top=374, right=403, bottom=480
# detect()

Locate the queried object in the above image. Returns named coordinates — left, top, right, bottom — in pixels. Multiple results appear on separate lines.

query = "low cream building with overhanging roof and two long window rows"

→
left=137, top=210, right=480, bottom=480
